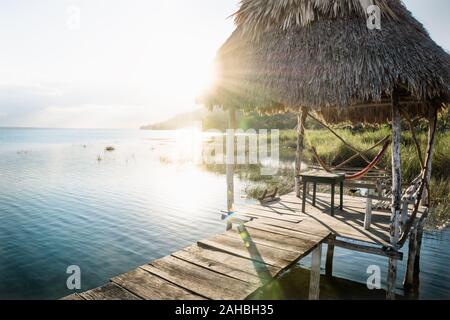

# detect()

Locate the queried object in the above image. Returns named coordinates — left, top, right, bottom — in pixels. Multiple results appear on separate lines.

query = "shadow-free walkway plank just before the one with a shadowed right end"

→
left=141, top=256, right=255, bottom=300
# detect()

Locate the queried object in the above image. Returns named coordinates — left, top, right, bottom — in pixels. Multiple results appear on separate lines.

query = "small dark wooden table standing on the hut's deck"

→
left=300, top=171, right=345, bottom=216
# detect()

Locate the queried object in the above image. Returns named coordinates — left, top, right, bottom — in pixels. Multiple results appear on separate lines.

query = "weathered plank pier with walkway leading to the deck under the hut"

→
left=64, top=193, right=425, bottom=300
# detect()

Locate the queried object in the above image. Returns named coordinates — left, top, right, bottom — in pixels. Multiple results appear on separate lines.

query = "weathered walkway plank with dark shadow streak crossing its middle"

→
left=198, top=235, right=298, bottom=269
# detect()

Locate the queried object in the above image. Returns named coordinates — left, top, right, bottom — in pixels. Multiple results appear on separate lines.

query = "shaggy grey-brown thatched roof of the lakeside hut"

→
left=203, top=0, right=450, bottom=122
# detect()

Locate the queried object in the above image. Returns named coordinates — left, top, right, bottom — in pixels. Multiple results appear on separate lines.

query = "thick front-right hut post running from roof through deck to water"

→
left=387, top=89, right=402, bottom=300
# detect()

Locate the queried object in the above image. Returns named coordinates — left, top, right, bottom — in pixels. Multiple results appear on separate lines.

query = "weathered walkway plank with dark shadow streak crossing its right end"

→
left=172, top=245, right=281, bottom=285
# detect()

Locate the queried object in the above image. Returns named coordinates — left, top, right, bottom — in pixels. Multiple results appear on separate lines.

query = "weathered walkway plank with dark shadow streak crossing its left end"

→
left=224, top=227, right=316, bottom=255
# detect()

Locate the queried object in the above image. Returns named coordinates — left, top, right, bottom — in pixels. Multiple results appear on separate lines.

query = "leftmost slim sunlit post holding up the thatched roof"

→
left=226, top=109, right=236, bottom=230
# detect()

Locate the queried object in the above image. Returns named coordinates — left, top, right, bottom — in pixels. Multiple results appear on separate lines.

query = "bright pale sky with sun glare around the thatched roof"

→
left=0, top=0, right=450, bottom=128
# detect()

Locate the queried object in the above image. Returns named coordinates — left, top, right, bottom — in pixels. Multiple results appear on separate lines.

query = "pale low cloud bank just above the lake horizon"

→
left=0, top=81, right=195, bottom=129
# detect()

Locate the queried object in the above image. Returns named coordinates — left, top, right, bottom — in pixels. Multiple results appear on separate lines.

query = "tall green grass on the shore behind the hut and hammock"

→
left=247, top=126, right=450, bottom=227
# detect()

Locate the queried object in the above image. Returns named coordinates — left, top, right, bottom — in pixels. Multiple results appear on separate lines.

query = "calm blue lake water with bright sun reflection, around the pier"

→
left=0, top=128, right=450, bottom=299
